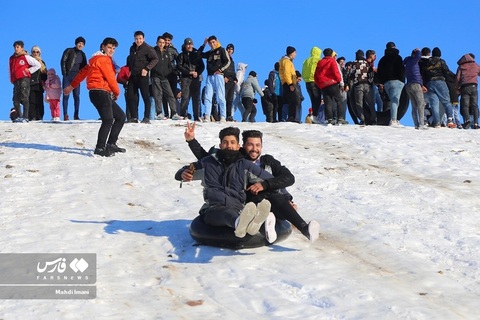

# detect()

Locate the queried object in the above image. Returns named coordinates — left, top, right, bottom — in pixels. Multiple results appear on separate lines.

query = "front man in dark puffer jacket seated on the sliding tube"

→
left=175, top=127, right=284, bottom=248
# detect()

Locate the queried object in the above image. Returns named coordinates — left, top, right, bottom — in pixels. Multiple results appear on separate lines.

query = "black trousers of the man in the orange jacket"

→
left=88, top=90, right=125, bottom=149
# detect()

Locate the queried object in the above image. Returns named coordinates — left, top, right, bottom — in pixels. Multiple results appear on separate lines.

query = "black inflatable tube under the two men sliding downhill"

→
left=190, top=216, right=292, bottom=250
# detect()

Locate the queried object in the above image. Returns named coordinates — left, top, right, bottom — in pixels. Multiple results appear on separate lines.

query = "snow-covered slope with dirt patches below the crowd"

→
left=0, top=120, right=480, bottom=319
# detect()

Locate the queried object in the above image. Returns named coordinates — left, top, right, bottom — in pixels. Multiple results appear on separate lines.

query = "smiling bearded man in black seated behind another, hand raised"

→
left=184, top=123, right=320, bottom=242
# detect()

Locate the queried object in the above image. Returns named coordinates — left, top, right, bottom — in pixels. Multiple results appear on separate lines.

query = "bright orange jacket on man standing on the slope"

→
left=70, top=54, right=120, bottom=97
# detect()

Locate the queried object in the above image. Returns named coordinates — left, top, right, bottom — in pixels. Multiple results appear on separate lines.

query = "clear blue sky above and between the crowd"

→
left=0, top=0, right=480, bottom=125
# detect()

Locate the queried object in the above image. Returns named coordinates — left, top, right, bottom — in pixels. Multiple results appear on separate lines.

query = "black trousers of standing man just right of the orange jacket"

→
left=127, top=75, right=152, bottom=119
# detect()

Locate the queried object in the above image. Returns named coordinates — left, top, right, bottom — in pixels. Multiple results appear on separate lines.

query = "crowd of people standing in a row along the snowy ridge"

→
left=10, top=31, right=480, bottom=129
